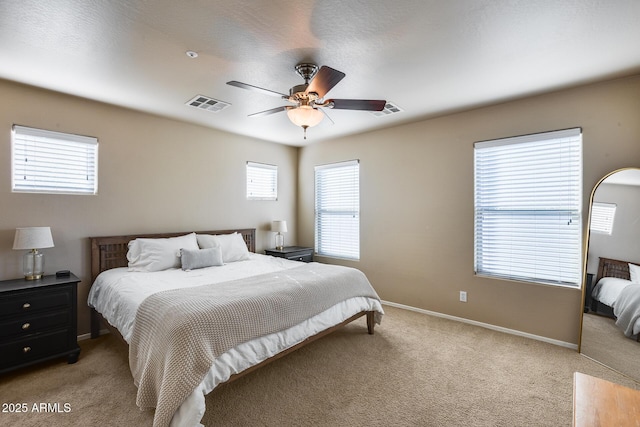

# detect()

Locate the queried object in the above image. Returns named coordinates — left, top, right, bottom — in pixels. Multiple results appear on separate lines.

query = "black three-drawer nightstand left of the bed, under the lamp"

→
left=0, top=274, right=80, bottom=374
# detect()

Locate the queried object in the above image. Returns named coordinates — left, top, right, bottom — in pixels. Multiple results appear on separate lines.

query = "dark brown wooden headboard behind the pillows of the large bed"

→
left=89, top=228, right=256, bottom=283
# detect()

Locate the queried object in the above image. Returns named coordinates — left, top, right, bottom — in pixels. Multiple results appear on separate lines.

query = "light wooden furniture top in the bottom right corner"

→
left=573, top=372, right=640, bottom=427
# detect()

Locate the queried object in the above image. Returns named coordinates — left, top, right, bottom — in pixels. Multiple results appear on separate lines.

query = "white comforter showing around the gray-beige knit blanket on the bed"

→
left=88, top=254, right=383, bottom=426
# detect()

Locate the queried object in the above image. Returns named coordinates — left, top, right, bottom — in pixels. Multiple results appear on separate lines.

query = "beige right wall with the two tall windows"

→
left=298, top=77, right=640, bottom=344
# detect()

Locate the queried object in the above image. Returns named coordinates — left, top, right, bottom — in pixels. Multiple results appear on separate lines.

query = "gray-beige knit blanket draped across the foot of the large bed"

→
left=129, top=262, right=380, bottom=426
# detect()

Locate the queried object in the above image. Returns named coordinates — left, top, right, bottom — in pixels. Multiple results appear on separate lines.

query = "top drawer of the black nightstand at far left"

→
left=0, top=286, right=73, bottom=318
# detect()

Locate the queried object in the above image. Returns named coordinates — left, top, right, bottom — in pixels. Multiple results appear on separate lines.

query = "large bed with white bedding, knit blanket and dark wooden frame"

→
left=88, top=229, right=384, bottom=426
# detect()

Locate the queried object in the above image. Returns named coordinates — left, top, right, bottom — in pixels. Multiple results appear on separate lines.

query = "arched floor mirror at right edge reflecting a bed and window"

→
left=580, top=169, right=640, bottom=380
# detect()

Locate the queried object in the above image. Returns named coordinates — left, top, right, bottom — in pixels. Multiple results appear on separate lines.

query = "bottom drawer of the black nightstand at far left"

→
left=0, top=329, right=70, bottom=370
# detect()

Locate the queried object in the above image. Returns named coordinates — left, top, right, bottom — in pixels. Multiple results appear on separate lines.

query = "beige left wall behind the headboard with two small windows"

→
left=0, top=80, right=298, bottom=333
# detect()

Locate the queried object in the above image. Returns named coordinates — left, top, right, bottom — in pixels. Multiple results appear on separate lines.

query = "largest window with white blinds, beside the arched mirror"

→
left=474, top=129, right=582, bottom=287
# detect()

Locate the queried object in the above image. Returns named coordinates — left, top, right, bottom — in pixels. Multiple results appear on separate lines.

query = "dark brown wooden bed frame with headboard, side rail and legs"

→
left=90, top=228, right=375, bottom=382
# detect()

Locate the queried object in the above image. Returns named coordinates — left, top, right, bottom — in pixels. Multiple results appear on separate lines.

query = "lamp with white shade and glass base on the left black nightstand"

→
left=13, top=227, right=53, bottom=280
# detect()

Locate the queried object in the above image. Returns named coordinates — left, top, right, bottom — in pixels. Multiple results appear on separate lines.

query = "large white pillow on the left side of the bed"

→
left=127, top=233, right=199, bottom=271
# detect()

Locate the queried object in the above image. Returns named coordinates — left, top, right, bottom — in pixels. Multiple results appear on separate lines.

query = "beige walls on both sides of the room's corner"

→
left=5, top=77, right=640, bottom=343
